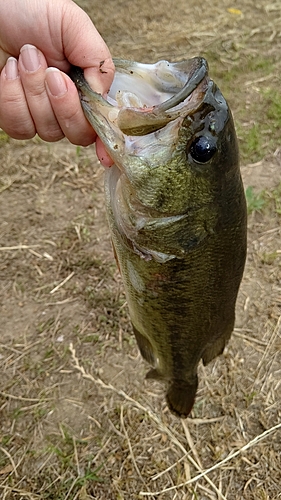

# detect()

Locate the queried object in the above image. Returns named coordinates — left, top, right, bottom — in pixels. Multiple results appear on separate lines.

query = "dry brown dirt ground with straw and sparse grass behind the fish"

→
left=0, top=0, right=281, bottom=500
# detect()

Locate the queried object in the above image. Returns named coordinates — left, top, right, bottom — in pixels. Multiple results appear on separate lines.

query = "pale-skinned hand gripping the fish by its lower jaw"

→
left=0, top=0, right=114, bottom=166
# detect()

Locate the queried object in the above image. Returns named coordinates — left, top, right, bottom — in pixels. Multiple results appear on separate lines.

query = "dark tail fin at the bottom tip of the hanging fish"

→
left=166, top=376, right=198, bottom=418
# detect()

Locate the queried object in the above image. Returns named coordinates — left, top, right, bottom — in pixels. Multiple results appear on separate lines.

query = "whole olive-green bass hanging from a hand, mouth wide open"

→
left=71, top=57, right=247, bottom=418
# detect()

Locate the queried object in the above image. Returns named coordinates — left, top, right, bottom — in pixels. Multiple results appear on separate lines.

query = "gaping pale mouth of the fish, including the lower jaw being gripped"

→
left=70, top=57, right=208, bottom=158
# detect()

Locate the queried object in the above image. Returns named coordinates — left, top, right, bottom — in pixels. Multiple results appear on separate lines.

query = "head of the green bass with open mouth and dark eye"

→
left=71, top=57, right=238, bottom=216
